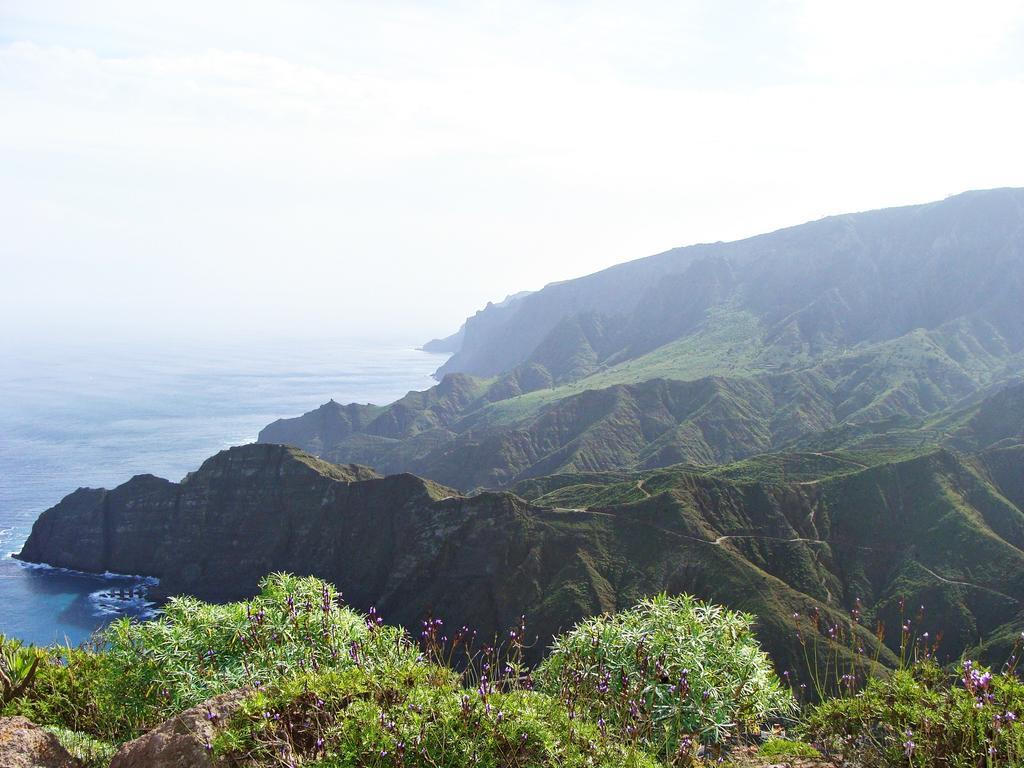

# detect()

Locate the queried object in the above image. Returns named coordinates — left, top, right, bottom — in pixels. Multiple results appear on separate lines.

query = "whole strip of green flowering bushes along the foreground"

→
left=0, top=574, right=1024, bottom=768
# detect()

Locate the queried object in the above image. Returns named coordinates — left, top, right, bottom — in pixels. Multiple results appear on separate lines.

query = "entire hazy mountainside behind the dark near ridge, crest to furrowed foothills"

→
left=259, top=189, right=1024, bottom=488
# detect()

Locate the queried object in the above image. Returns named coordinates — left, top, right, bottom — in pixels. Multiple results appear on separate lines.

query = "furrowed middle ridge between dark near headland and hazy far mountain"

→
left=259, top=358, right=1013, bottom=488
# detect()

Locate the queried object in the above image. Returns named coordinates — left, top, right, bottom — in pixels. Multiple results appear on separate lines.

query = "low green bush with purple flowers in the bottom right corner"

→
left=804, top=660, right=1024, bottom=768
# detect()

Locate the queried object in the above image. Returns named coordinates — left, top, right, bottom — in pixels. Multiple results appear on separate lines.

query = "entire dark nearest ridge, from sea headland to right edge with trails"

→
left=19, top=444, right=1024, bottom=668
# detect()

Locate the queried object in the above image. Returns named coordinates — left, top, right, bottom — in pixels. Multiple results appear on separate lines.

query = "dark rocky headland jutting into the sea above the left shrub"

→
left=17, top=444, right=454, bottom=600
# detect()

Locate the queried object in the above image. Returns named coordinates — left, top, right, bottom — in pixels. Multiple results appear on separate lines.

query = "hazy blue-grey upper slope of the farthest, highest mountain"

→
left=438, top=189, right=1024, bottom=377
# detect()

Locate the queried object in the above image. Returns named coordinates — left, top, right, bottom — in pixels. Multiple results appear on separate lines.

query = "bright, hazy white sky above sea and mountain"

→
left=0, top=0, right=1024, bottom=341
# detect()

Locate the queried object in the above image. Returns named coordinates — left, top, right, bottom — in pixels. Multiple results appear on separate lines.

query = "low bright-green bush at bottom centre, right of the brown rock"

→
left=213, top=663, right=656, bottom=768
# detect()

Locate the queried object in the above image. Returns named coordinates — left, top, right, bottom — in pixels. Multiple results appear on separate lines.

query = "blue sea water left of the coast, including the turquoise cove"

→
left=0, top=340, right=442, bottom=644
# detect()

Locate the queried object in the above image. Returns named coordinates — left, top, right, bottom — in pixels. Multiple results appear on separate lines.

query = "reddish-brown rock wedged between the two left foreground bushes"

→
left=111, top=690, right=246, bottom=768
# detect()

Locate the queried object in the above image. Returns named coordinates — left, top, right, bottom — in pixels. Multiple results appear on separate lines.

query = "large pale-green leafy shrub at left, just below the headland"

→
left=96, top=573, right=416, bottom=737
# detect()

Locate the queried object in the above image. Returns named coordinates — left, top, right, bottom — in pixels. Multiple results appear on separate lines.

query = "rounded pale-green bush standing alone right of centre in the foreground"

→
left=538, top=595, right=795, bottom=759
